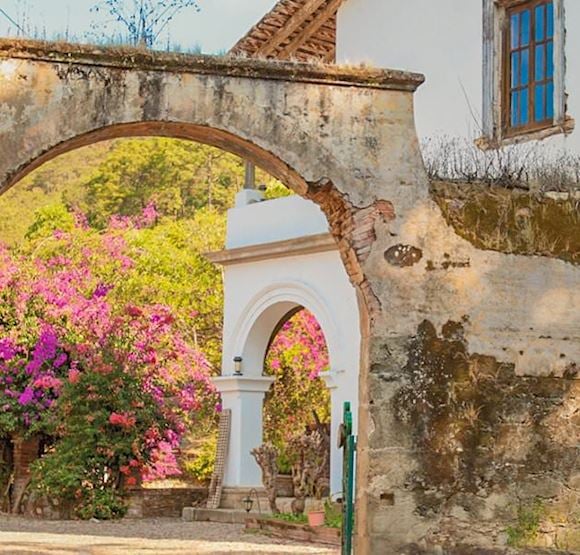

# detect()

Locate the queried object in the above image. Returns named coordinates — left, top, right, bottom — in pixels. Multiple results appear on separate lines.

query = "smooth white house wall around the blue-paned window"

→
left=337, top=0, right=580, bottom=153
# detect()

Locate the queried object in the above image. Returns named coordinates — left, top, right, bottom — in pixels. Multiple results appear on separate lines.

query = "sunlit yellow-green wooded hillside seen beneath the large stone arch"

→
left=0, top=138, right=287, bottom=245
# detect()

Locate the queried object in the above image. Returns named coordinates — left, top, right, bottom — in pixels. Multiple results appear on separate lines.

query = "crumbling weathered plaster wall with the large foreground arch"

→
left=0, top=41, right=580, bottom=554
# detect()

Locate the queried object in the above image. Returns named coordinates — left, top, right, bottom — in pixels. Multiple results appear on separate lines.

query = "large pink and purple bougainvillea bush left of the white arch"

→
left=0, top=205, right=217, bottom=490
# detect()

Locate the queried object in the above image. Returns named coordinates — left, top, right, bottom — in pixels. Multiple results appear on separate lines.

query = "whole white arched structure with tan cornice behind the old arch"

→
left=208, top=191, right=360, bottom=493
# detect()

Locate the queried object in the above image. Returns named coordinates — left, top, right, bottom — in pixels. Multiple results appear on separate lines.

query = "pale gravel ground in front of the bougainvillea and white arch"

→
left=0, top=515, right=339, bottom=555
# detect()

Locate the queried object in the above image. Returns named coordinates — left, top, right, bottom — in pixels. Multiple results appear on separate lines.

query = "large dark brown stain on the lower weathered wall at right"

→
left=394, top=321, right=580, bottom=547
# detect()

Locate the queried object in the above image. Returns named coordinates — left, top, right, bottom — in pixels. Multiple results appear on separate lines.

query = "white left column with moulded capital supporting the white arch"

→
left=212, top=376, right=274, bottom=487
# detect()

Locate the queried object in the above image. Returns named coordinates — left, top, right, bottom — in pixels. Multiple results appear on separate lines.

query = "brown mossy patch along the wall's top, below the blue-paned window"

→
left=431, top=182, right=580, bottom=264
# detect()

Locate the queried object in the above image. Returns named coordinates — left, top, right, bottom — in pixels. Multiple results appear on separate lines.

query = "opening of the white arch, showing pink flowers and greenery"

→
left=264, top=306, right=336, bottom=499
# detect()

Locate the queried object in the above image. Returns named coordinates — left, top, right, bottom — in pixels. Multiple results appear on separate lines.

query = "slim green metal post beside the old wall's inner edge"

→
left=340, top=401, right=356, bottom=555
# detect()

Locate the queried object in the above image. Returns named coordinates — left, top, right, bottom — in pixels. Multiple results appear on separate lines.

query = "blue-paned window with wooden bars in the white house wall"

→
left=505, top=0, right=554, bottom=130
